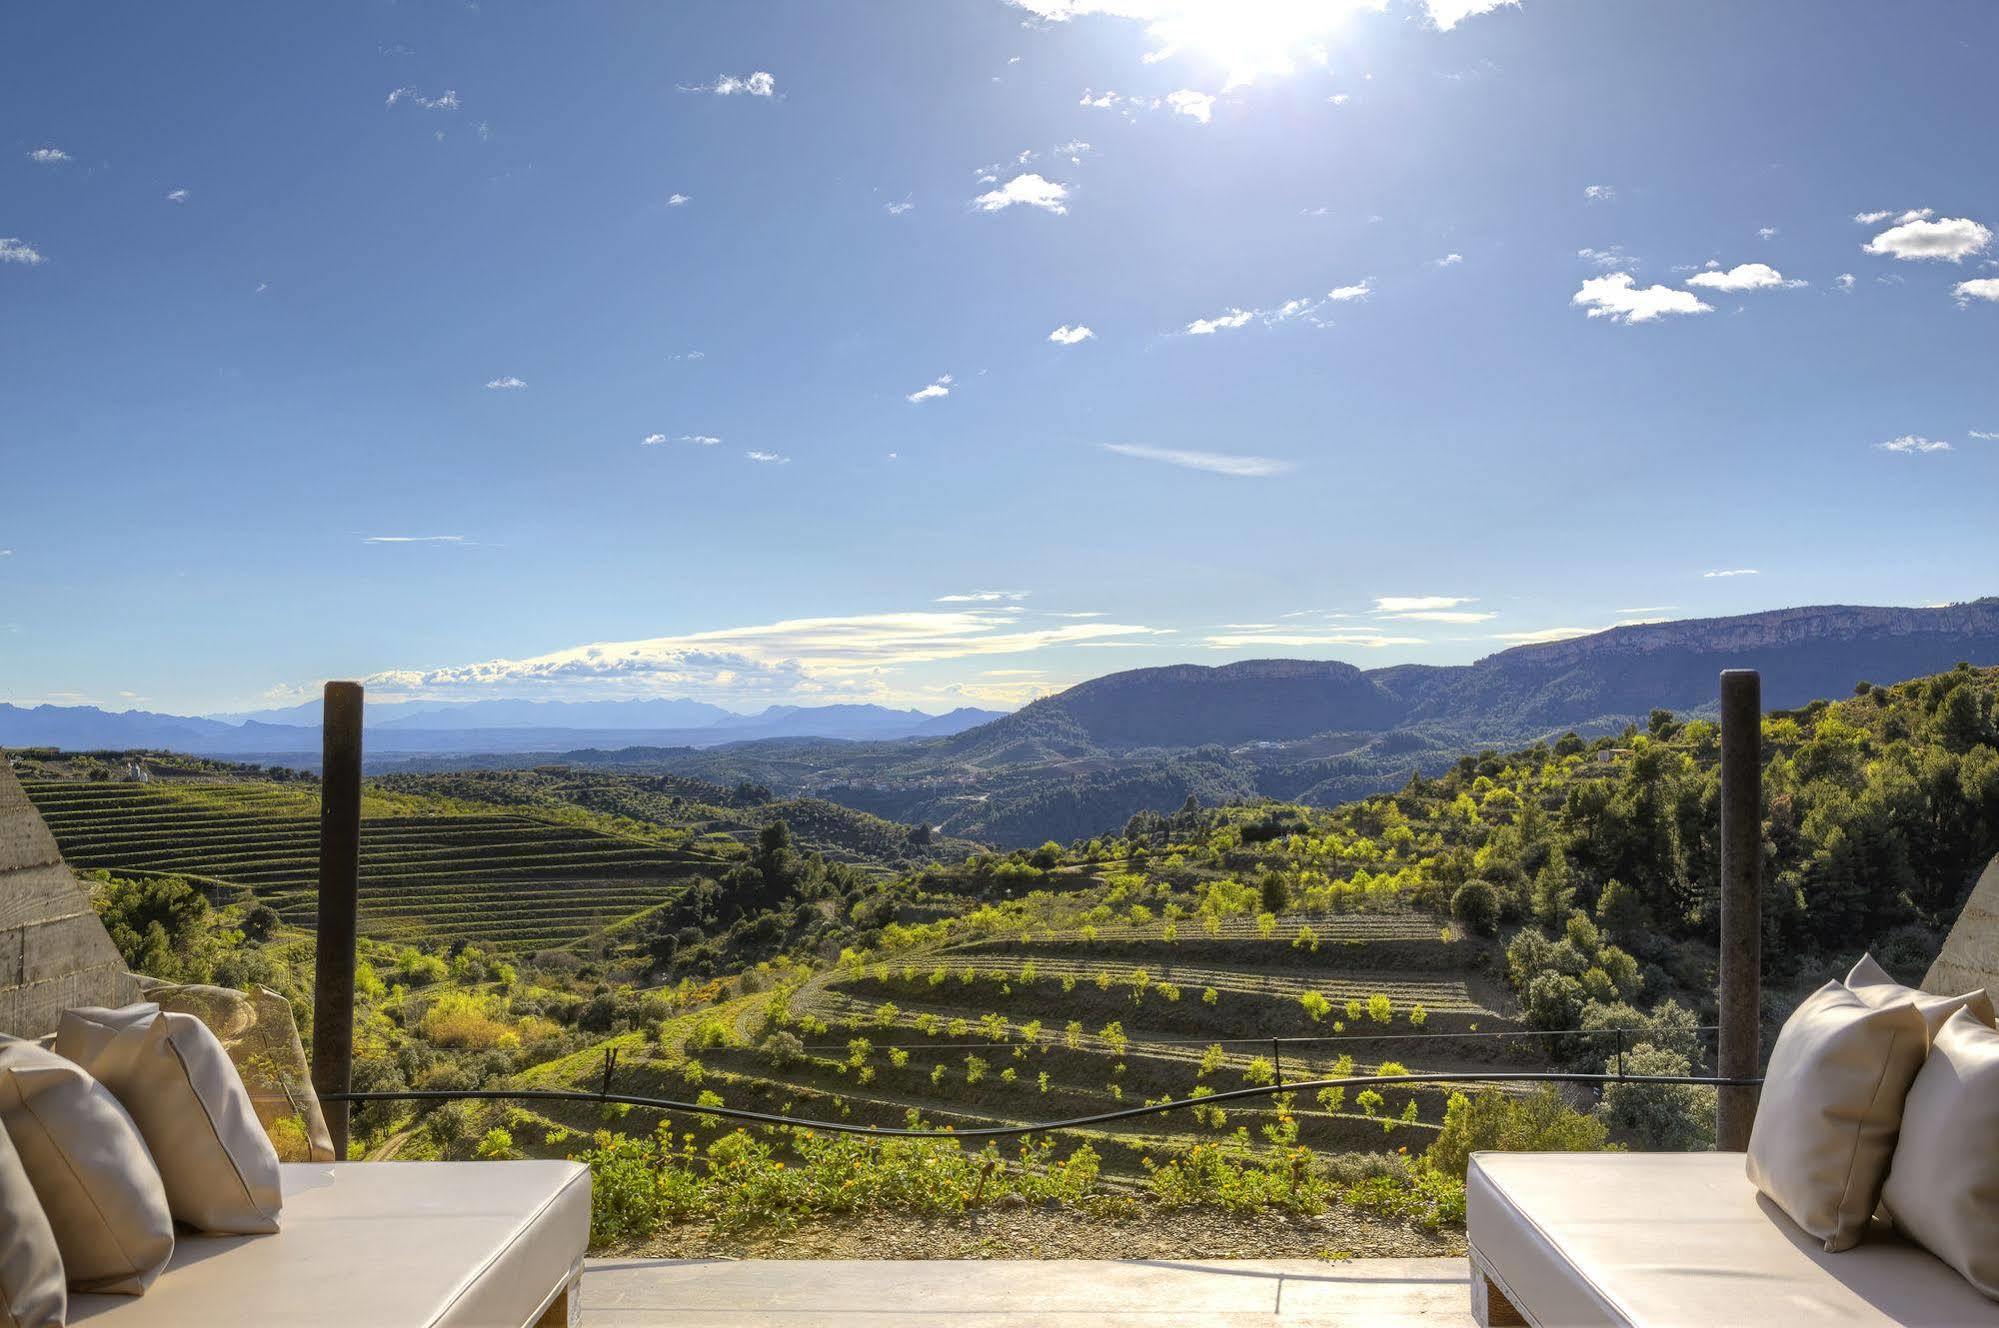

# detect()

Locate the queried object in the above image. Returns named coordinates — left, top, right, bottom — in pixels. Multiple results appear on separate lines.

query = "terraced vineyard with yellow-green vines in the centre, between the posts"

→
left=538, top=912, right=1545, bottom=1180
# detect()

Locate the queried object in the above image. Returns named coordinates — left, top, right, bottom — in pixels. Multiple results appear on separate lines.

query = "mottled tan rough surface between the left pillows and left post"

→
left=140, top=978, right=334, bottom=1162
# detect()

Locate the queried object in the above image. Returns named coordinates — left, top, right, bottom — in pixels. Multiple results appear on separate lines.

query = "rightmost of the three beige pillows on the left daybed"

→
left=56, top=1002, right=284, bottom=1236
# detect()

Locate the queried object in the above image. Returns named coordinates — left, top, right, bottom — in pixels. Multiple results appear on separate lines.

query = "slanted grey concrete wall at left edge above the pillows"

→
left=0, top=752, right=138, bottom=1038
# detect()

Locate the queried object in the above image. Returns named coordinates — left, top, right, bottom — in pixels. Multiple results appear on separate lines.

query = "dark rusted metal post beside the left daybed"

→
left=312, top=682, right=362, bottom=1160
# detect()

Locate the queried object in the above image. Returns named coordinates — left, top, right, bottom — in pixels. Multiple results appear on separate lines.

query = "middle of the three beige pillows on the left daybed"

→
left=0, top=1036, right=174, bottom=1296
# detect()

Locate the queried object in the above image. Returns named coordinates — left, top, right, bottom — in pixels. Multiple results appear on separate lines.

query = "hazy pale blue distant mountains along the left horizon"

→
left=0, top=700, right=1001, bottom=758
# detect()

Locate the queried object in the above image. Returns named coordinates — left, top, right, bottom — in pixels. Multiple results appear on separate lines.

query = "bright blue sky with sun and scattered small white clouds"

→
left=0, top=0, right=1999, bottom=712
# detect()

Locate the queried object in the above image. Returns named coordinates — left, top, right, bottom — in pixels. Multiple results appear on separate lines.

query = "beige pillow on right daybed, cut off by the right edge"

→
left=1881, top=1010, right=1999, bottom=1300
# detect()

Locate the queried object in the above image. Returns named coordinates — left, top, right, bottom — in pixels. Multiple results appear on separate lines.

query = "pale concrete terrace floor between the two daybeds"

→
left=582, top=1258, right=1471, bottom=1328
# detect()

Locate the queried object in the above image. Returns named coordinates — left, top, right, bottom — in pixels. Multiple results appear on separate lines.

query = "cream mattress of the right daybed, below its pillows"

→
left=1465, top=1152, right=1999, bottom=1328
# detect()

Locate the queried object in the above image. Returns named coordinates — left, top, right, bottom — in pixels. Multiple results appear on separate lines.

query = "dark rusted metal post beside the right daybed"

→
left=1715, top=668, right=1763, bottom=1152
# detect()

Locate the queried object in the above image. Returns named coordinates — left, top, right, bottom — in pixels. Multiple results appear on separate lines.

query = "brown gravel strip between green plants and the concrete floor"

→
left=618, top=1204, right=1465, bottom=1258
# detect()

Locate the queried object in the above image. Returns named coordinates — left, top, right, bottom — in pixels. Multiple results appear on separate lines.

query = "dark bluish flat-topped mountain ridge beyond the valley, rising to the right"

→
left=591, top=598, right=1999, bottom=846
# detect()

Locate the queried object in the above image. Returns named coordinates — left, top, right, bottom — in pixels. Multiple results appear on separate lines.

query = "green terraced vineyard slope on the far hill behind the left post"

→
left=26, top=780, right=718, bottom=950
